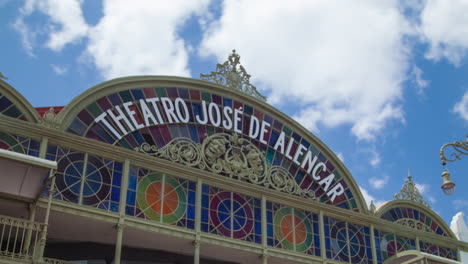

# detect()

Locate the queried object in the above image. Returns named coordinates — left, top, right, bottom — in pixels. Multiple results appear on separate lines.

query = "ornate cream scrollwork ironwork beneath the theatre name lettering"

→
left=135, top=133, right=315, bottom=199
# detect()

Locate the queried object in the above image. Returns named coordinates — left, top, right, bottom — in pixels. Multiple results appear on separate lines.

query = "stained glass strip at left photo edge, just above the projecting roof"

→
left=0, top=132, right=40, bottom=157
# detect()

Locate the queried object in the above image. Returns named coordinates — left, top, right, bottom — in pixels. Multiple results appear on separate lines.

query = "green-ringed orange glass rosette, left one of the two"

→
left=137, top=173, right=187, bottom=224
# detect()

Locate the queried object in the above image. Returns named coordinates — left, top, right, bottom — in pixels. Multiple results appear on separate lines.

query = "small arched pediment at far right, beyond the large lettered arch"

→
left=375, top=200, right=457, bottom=239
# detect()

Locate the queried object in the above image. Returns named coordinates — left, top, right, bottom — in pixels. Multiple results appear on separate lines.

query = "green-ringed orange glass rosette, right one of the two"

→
left=274, top=208, right=313, bottom=252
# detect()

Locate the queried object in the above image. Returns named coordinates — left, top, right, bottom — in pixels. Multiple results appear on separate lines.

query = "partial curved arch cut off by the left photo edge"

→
left=0, top=80, right=40, bottom=123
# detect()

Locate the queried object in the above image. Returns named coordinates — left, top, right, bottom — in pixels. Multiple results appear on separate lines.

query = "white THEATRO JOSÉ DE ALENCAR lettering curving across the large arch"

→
left=94, top=97, right=344, bottom=202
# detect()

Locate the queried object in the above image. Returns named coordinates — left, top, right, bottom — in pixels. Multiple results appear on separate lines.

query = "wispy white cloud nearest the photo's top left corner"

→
left=13, top=0, right=88, bottom=55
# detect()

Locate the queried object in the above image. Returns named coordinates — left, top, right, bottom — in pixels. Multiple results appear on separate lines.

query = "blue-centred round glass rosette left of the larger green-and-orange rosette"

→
left=56, top=153, right=111, bottom=205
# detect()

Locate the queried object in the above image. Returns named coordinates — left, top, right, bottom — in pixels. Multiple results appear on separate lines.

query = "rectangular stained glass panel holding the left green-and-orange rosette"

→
left=126, top=168, right=195, bottom=229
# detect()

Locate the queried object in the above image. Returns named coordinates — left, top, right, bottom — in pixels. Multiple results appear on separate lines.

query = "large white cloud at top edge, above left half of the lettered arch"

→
left=83, top=0, right=208, bottom=78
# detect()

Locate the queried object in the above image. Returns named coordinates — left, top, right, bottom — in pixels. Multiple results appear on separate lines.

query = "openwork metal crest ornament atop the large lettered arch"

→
left=200, top=50, right=266, bottom=101
